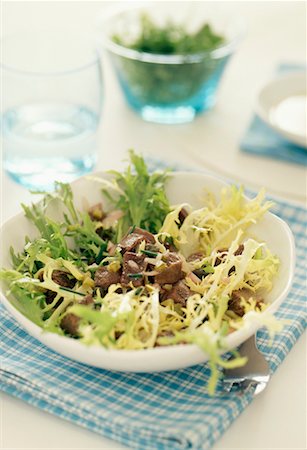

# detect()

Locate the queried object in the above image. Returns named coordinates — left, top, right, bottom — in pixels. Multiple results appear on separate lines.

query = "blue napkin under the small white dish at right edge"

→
left=240, top=64, right=307, bottom=166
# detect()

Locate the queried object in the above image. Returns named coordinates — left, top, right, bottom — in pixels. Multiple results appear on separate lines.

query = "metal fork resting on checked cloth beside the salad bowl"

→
left=223, top=335, right=271, bottom=396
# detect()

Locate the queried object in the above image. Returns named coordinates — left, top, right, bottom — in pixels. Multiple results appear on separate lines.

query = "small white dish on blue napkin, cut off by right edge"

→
left=256, top=71, right=307, bottom=147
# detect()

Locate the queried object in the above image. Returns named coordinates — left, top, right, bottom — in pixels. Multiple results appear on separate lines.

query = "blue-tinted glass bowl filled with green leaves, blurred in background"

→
left=105, top=11, right=243, bottom=123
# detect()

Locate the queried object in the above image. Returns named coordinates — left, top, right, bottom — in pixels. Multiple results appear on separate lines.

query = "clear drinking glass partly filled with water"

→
left=1, top=30, right=103, bottom=190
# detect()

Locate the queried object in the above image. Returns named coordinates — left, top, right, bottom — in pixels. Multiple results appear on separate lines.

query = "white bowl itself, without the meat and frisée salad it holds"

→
left=0, top=172, right=295, bottom=372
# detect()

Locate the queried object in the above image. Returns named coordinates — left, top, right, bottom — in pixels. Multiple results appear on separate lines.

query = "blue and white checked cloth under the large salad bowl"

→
left=0, top=164, right=306, bottom=450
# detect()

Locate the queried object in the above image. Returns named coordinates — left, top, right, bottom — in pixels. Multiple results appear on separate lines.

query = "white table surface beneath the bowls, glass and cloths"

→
left=0, top=1, right=306, bottom=450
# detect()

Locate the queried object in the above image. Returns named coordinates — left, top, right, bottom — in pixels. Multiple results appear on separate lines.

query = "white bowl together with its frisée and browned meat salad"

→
left=0, top=151, right=294, bottom=392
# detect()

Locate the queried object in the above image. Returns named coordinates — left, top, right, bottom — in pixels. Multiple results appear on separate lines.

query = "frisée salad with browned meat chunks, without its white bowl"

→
left=0, top=151, right=280, bottom=394
